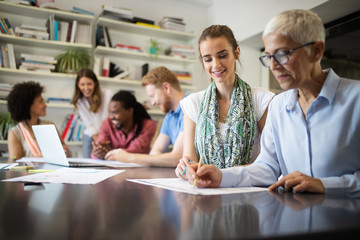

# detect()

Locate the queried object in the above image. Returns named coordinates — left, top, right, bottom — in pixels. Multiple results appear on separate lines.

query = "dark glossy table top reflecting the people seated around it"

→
left=0, top=164, right=360, bottom=239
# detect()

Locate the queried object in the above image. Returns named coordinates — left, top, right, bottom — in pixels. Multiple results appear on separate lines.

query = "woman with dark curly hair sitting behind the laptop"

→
left=8, top=81, right=70, bottom=160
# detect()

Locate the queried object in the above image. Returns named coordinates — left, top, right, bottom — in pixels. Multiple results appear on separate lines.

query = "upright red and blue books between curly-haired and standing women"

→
left=61, top=113, right=85, bottom=142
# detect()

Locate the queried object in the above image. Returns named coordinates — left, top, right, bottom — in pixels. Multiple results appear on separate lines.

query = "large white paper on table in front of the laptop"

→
left=3, top=168, right=125, bottom=184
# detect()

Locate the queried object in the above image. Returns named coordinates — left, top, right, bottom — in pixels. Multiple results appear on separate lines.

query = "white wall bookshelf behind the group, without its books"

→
left=0, top=1, right=197, bottom=157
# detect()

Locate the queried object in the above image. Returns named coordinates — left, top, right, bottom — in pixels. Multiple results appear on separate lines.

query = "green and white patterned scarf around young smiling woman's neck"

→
left=195, top=75, right=256, bottom=169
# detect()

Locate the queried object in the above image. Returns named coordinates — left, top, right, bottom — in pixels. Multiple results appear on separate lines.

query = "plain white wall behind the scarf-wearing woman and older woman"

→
left=208, top=0, right=326, bottom=88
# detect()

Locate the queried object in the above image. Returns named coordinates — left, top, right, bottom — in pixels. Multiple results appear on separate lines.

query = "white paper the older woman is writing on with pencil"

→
left=127, top=178, right=267, bottom=195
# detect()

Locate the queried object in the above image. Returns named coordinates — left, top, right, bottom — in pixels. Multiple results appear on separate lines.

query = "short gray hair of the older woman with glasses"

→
left=262, top=9, right=325, bottom=44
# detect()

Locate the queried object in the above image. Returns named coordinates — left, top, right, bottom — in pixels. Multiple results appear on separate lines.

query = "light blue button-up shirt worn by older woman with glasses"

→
left=221, top=69, right=360, bottom=195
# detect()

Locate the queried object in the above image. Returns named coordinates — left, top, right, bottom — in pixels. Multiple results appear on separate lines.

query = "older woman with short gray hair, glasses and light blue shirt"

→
left=183, top=10, right=360, bottom=195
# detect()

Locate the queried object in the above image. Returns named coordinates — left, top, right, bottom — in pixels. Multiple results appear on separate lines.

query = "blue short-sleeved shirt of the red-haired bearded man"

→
left=160, top=104, right=184, bottom=145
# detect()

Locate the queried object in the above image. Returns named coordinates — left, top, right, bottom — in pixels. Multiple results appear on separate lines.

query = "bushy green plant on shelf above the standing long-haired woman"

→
left=56, top=49, right=90, bottom=73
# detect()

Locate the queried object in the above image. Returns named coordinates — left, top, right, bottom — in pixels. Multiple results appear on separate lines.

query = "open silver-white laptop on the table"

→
left=32, top=124, right=106, bottom=167
